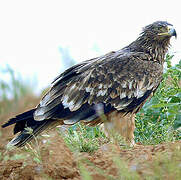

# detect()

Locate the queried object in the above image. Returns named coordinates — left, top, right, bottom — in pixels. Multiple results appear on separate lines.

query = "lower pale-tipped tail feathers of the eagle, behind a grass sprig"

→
left=7, top=120, right=55, bottom=147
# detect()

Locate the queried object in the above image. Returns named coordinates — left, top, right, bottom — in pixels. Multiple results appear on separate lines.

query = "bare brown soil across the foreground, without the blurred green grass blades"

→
left=0, top=127, right=181, bottom=180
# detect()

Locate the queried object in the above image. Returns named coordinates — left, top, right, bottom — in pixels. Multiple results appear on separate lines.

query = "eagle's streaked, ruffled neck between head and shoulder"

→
left=127, top=36, right=170, bottom=64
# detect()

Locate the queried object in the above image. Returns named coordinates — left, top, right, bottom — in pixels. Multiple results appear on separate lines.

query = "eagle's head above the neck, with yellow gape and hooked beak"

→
left=142, top=21, right=177, bottom=42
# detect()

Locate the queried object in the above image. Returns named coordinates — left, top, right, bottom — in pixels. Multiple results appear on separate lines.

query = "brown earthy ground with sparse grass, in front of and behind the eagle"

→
left=0, top=97, right=181, bottom=180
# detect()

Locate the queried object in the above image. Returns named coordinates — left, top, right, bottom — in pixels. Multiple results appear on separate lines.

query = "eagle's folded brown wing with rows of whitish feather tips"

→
left=34, top=52, right=162, bottom=120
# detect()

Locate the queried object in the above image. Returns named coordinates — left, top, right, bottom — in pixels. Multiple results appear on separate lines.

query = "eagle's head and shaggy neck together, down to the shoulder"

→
left=126, top=21, right=177, bottom=64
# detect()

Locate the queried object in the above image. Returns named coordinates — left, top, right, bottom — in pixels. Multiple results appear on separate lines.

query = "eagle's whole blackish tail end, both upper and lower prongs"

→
left=2, top=109, right=55, bottom=147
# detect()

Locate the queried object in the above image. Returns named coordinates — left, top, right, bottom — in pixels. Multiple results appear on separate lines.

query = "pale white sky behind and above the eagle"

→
left=0, top=0, right=181, bottom=94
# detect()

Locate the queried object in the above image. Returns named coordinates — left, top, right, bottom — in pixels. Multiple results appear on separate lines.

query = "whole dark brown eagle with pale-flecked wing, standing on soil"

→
left=2, top=21, right=176, bottom=147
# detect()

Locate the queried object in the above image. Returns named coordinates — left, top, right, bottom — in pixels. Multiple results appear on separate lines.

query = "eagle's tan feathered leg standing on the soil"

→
left=103, top=112, right=135, bottom=146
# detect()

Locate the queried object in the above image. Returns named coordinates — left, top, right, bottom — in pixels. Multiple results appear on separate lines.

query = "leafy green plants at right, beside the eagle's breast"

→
left=135, top=55, right=181, bottom=144
